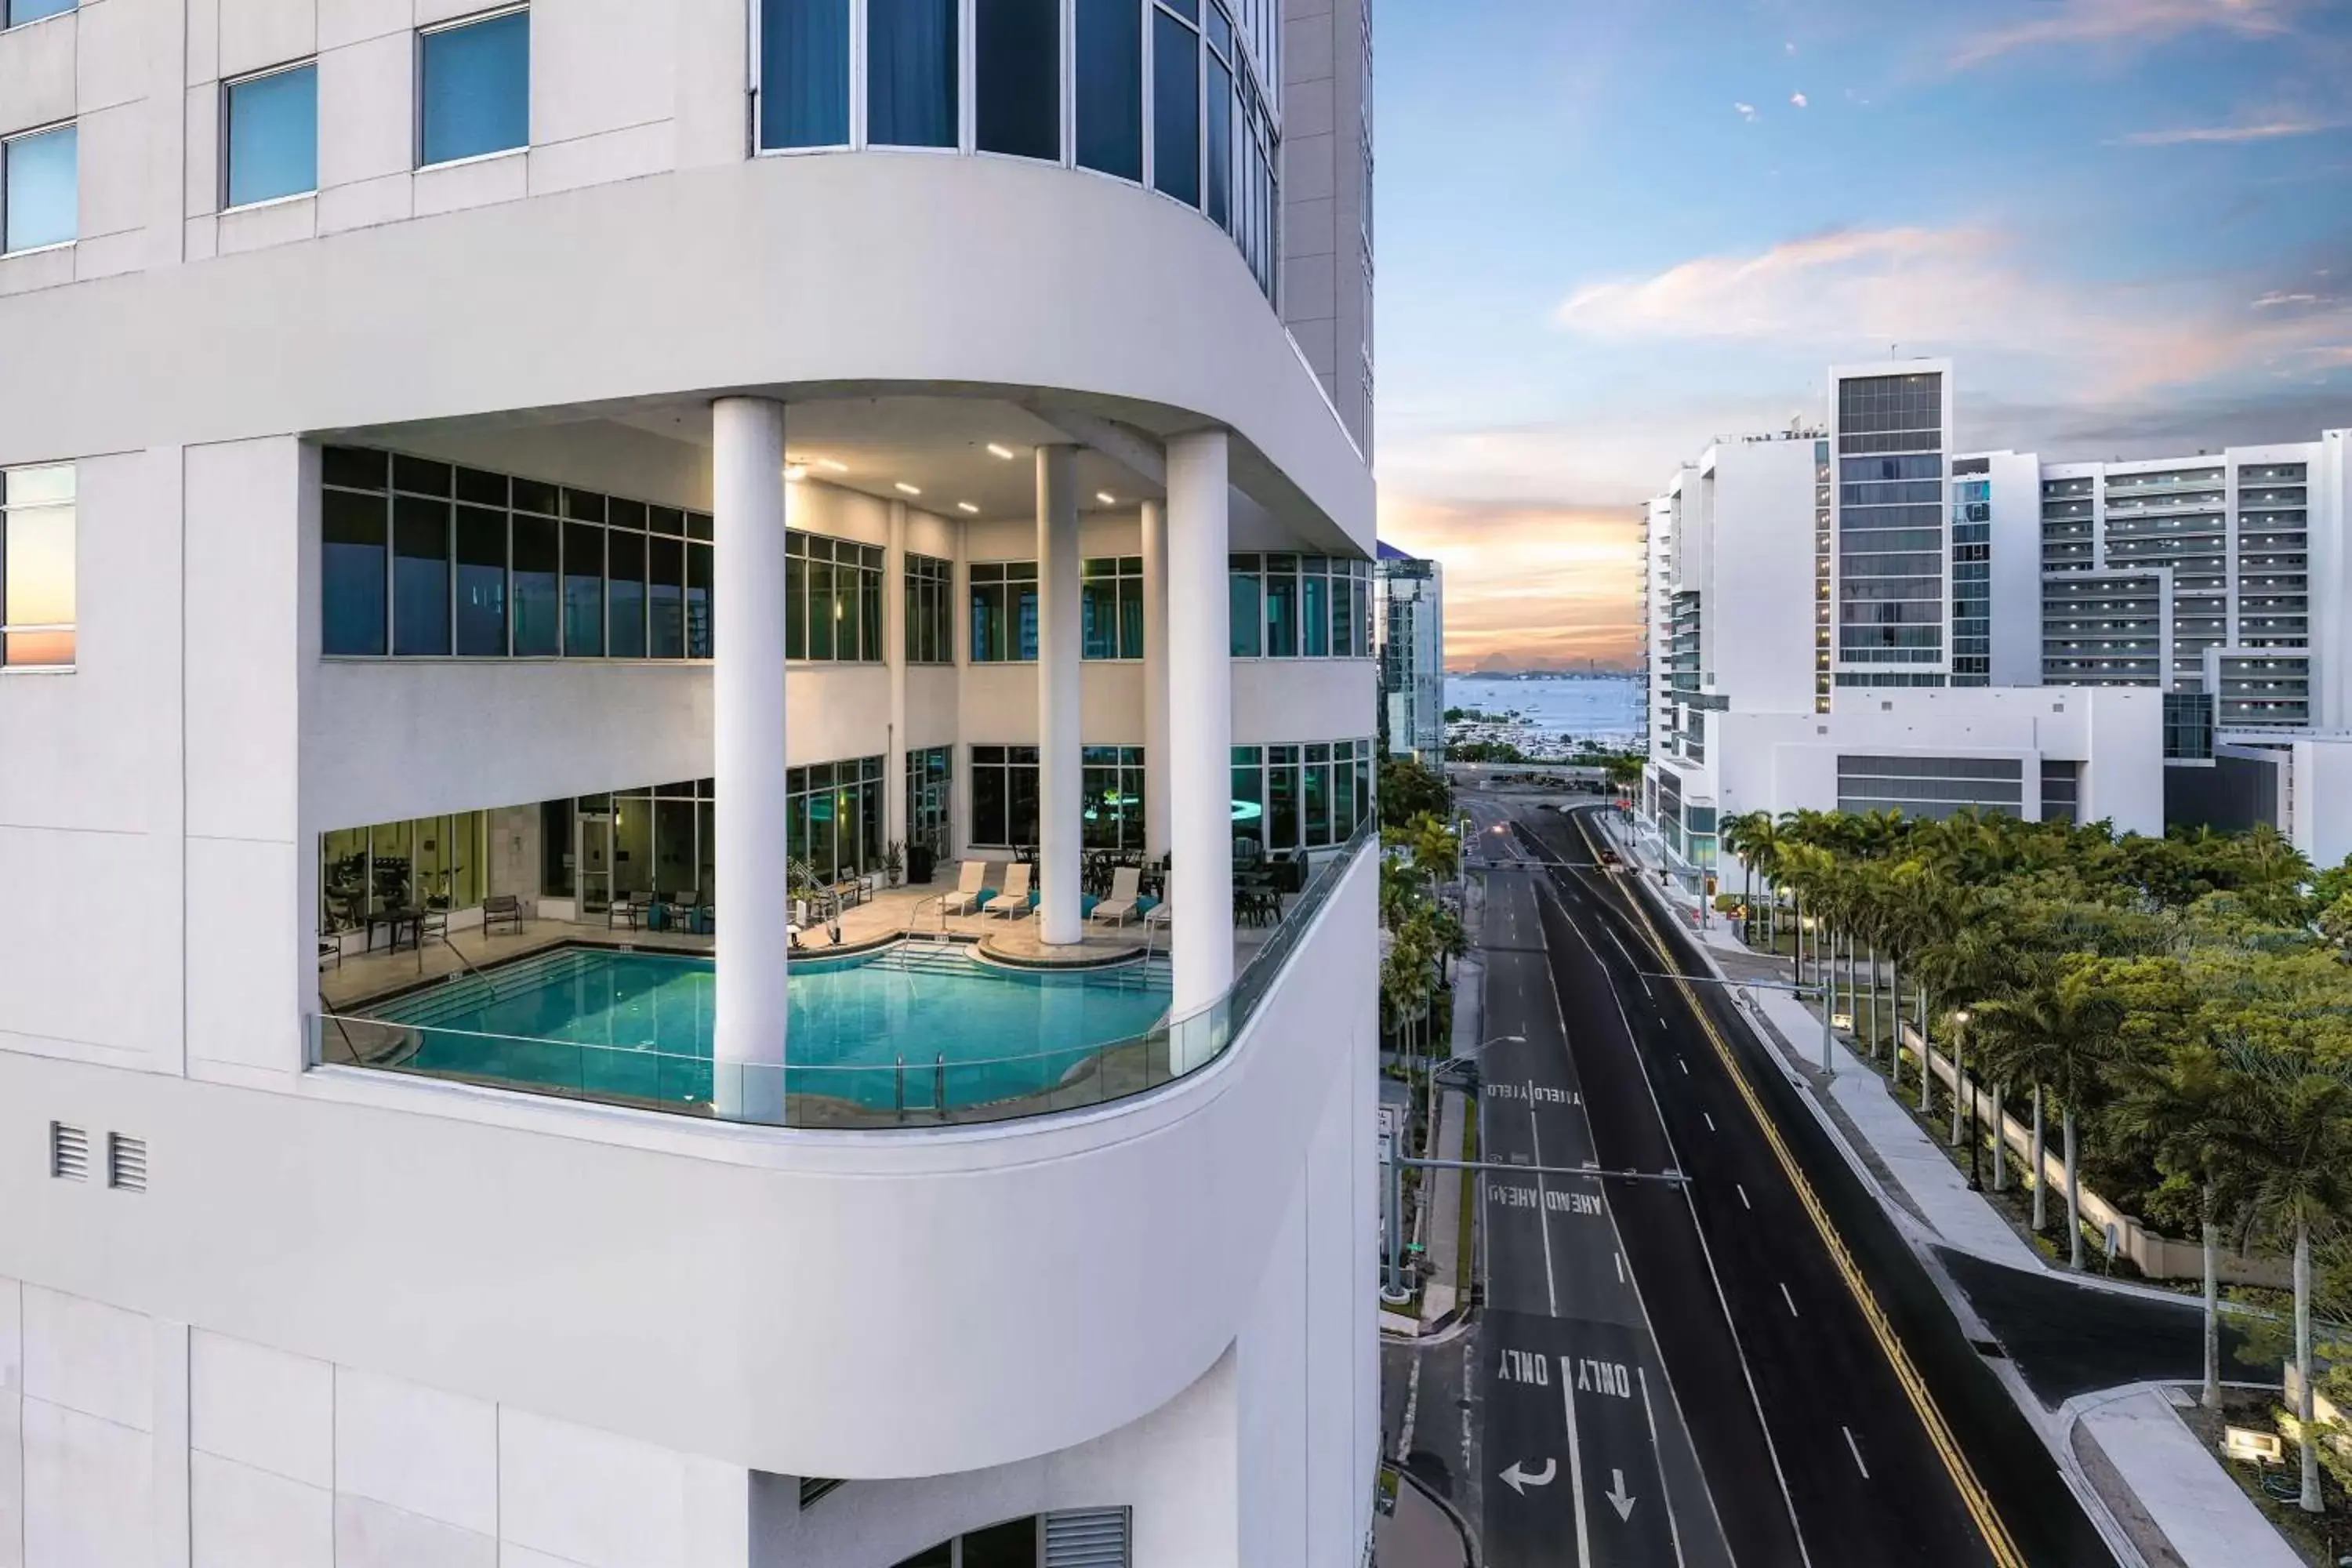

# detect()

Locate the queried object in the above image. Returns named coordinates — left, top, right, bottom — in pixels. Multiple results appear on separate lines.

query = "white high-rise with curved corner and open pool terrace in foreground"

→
left=0, top=0, right=1378, bottom=1568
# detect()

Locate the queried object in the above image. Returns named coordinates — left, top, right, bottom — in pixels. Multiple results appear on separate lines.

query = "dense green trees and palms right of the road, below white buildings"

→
left=1722, top=811, right=2352, bottom=1512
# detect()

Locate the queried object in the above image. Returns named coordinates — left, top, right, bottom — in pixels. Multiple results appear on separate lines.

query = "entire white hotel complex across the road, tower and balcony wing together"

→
left=1642, top=360, right=2352, bottom=893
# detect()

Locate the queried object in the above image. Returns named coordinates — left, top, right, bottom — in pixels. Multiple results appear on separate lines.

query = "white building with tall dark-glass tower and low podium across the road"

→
left=1642, top=360, right=2164, bottom=893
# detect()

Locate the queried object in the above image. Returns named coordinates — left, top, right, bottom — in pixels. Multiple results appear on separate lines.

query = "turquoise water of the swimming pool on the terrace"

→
left=369, top=947, right=1169, bottom=1109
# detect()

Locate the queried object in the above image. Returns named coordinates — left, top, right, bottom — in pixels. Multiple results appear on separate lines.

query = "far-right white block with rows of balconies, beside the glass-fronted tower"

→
left=1955, top=430, right=2352, bottom=865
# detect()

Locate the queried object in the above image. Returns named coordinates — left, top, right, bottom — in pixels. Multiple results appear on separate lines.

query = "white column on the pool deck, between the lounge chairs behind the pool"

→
left=1037, top=447, right=1087, bottom=945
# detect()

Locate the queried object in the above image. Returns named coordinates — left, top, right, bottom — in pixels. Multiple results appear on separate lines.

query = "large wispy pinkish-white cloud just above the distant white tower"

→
left=1552, top=228, right=2352, bottom=400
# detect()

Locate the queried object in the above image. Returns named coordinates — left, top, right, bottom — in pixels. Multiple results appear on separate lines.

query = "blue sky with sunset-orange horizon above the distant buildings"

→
left=1376, top=0, right=2352, bottom=668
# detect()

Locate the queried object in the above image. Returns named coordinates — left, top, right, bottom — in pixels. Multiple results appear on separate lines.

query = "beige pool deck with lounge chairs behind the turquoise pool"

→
left=318, top=879, right=1275, bottom=1013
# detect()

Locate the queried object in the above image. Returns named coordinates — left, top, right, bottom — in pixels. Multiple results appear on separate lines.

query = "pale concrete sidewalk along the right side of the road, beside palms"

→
left=1599, top=813, right=2300, bottom=1568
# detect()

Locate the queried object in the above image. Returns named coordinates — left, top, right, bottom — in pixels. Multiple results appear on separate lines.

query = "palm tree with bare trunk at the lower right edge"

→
left=2227, top=1044, right=2352, bottom=1514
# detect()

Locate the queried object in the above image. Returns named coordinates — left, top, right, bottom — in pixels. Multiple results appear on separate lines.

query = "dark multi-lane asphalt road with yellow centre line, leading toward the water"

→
left=1468, top=797, right=2112, bottom=1568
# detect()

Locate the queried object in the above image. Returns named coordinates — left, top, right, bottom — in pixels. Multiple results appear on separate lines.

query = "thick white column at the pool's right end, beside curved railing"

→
left=1171, top=430, right=1232, bottom=1018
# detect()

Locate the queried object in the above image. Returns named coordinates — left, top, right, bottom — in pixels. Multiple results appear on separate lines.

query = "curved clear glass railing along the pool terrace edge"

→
left=310, top=818, right=1378, bottom=1128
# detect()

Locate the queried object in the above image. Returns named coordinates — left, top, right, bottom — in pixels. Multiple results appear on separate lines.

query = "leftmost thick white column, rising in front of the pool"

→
left=710, top=397, right=793, bottom=1121
